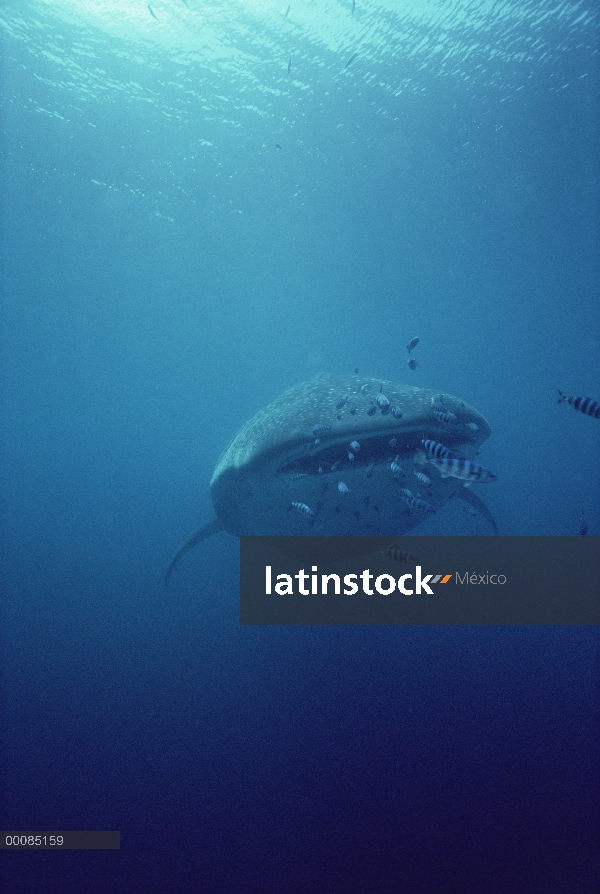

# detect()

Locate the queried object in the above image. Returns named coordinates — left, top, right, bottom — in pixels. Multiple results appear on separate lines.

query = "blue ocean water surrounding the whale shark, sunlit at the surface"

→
left=0, top=0, right=600, bottom=894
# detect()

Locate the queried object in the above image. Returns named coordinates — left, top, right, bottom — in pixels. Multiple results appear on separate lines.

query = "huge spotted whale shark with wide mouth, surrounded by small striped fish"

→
left=166, top=374, right=498, bottom=583
